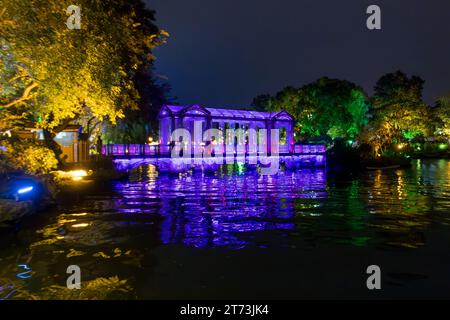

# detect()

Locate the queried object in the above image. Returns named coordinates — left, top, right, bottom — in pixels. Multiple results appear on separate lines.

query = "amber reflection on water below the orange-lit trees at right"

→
left=362, top=161, right=442, bottom=248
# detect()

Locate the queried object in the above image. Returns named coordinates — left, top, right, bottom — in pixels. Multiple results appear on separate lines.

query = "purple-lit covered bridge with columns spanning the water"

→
left=102, top=105, right=326, bottom=172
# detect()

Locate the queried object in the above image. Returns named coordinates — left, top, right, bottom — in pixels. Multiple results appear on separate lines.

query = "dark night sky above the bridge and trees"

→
left=146, top=0, right=450, bottom=107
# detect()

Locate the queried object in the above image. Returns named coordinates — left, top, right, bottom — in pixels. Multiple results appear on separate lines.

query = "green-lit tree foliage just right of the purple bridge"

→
left=253, top=78, right=368, bottom=139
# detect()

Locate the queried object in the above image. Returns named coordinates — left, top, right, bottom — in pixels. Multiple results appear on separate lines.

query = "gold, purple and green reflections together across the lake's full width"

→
left=0, top=160, right=450, bottom=299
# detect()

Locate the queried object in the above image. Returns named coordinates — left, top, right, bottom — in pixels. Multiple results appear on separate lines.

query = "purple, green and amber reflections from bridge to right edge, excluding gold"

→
left=116, top=160, right=450, bottom=248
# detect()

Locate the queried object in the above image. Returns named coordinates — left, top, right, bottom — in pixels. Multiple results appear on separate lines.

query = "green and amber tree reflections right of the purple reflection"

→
left=294, top=160, right=450, bottom=248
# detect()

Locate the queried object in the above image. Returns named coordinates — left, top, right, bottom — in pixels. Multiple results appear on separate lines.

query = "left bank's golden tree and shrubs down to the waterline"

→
left=0, top=0, right=169, bottom=221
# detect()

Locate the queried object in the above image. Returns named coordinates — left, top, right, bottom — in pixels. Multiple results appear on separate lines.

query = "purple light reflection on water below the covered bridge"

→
left=115, top=166, right=327, bottom=248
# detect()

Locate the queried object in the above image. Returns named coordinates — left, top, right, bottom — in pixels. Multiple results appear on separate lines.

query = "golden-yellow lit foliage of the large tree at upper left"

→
left=0, top=0, right=167, bottom=131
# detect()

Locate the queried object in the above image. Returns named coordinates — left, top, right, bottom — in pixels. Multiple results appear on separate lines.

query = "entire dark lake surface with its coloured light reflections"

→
left=0, top=160, right=450, bottom=299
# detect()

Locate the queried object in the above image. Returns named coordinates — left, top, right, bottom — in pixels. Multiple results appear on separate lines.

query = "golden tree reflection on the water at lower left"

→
left=0, top=199, right=162, bottom=299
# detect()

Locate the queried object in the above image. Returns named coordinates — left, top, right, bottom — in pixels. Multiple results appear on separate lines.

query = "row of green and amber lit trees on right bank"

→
left=252, top=71, right=450, bottom=163
